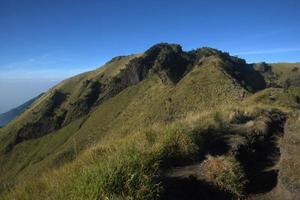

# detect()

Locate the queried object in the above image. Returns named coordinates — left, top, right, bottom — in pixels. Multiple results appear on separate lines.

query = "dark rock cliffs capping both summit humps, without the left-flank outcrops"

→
left=107, top=43, right=266, bottom=100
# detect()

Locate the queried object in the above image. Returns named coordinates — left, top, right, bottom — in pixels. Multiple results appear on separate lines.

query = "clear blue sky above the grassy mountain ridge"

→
left=0, top=0, right=300, bottom=113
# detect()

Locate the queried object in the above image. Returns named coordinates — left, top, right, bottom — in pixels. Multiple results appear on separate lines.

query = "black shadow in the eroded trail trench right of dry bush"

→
left=237, top=111, right=286, bottom=194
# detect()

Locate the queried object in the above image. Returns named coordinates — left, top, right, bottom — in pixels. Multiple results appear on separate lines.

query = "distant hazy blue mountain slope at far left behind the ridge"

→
left=0, top=94, right=42, bottom=126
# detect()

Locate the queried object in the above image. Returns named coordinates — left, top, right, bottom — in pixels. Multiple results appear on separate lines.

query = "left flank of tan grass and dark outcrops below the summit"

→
left=0, top=55, right=139, bottom=151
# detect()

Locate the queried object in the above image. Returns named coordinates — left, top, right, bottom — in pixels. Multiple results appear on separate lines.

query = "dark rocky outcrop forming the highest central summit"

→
left=104, top=44, right=192, bottom=99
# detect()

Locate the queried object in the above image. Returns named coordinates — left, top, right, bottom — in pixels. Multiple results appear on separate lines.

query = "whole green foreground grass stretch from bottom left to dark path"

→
left=4, top=125, right=204, bottom=199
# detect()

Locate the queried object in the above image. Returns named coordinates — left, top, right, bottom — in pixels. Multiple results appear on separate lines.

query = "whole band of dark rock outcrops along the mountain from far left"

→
left=5, top=43, right=266, bottom=151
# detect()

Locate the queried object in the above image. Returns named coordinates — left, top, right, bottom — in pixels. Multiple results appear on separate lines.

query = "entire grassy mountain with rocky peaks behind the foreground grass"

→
left=0, top=44, right=258, bottom=190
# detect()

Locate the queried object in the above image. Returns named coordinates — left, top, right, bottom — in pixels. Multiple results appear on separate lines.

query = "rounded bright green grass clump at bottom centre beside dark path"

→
left=73, top=147, right=162, bottom=199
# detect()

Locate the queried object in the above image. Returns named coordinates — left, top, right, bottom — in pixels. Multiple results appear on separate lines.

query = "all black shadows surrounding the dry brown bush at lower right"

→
left=162, top=112, right=286, bottom=200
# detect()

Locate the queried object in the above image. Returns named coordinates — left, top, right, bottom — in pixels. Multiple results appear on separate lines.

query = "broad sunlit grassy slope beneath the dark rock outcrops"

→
left=0, top=55, right=245, bottom=193
